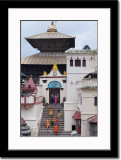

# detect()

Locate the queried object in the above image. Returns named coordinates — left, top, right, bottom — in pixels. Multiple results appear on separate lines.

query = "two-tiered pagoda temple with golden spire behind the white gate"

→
left=21, top=21, right=75, bottom=81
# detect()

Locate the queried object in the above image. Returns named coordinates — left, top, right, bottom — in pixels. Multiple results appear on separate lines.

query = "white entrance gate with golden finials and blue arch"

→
left=39, top=62, right=67, bottom=104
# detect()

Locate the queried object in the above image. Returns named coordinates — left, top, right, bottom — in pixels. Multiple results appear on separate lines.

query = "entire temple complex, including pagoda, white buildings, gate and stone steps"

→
left=21, top=21, right=98, bottom=137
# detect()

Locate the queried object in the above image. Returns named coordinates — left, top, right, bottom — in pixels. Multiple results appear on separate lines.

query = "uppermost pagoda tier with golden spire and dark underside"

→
left=25, top=21, right=75, bottom=52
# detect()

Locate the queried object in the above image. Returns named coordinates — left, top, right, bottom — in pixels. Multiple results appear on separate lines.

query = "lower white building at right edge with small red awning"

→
left=78, top=72, right=98, bottom=136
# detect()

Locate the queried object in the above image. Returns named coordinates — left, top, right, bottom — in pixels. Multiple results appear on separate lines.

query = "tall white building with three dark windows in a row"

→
left=64, top=49, right=97, bottom=136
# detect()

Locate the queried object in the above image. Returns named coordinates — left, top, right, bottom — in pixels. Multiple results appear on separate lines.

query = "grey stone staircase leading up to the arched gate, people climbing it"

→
left=38, top=104, right=71, bottom=136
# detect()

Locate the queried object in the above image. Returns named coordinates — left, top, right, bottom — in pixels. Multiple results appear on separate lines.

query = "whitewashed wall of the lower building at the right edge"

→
left=78, top=79, right=98, bottom=136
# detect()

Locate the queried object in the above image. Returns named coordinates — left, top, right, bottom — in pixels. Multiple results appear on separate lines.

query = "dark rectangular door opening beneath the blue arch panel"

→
left=49, top=88, right=60, bottom=104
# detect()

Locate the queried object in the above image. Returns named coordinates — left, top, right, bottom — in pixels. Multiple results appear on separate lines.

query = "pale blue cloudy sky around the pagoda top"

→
left=21, top=21, right=97, bottom=58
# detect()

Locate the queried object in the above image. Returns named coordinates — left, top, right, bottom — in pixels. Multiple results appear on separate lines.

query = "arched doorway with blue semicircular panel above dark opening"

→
left=48, top=81, right=62, bottom=104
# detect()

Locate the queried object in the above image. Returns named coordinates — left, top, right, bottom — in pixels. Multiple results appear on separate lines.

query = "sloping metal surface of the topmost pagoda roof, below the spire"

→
left=25, top=32, right=75, bottom=39
